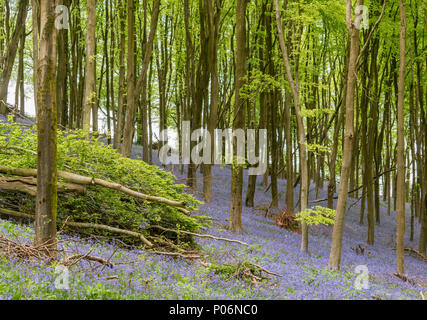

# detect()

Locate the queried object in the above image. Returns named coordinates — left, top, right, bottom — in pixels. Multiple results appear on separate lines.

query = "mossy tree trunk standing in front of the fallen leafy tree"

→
left=35, top=0, right=57, bottom=258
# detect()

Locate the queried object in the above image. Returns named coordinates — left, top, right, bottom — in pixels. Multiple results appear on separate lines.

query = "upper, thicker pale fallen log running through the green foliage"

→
left=0, top=166, right=190, bottom=215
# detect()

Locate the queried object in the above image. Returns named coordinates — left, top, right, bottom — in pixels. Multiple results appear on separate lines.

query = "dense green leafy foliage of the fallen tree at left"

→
left=0, top=119, right=205, bottom=245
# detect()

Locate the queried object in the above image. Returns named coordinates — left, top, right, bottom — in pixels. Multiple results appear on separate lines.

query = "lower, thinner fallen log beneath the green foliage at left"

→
left=0, top=208, right=153, bottom=247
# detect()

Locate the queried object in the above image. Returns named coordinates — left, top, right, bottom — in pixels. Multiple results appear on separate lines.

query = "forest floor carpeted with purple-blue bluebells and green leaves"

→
left=0, top=117, right=427, bottom=300
